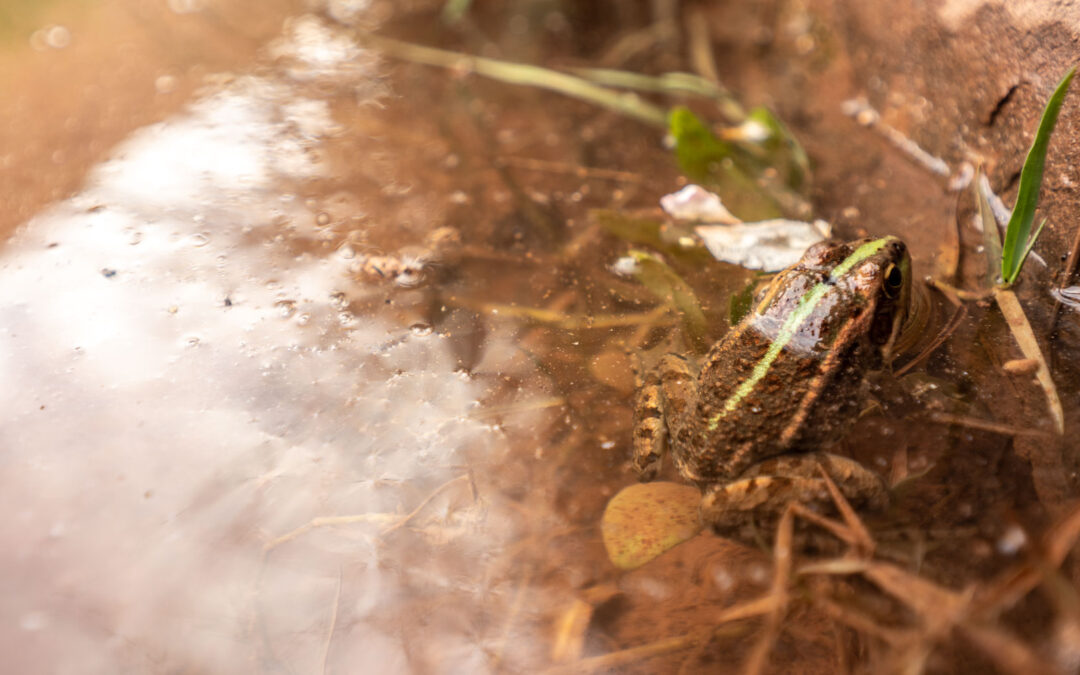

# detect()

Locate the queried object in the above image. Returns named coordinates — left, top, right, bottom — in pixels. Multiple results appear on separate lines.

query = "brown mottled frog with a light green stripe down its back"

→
left=632, top=237, right=915, bottom=539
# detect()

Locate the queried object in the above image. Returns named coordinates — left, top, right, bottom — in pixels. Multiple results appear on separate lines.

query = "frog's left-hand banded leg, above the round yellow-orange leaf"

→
left=633, top=354, right=698, bottom=481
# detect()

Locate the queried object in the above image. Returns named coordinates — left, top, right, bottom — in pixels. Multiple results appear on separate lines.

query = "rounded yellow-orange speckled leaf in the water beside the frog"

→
left=600, top=483, right=701, bottom=569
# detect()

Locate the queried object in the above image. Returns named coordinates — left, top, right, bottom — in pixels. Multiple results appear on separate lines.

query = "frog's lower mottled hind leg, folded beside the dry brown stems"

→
left=701, top=453, right=889, bottom=539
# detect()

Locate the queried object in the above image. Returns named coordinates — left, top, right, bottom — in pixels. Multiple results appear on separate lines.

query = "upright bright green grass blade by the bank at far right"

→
left=1001, top=67, right=1076, bottom=285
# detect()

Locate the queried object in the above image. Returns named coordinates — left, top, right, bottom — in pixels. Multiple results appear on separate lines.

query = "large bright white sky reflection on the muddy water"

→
left=0, top=19, right=527, bottom=673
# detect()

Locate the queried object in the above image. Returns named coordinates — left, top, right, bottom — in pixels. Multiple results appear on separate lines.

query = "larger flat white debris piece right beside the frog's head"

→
left=694, top=218, right=832, bottom=272
